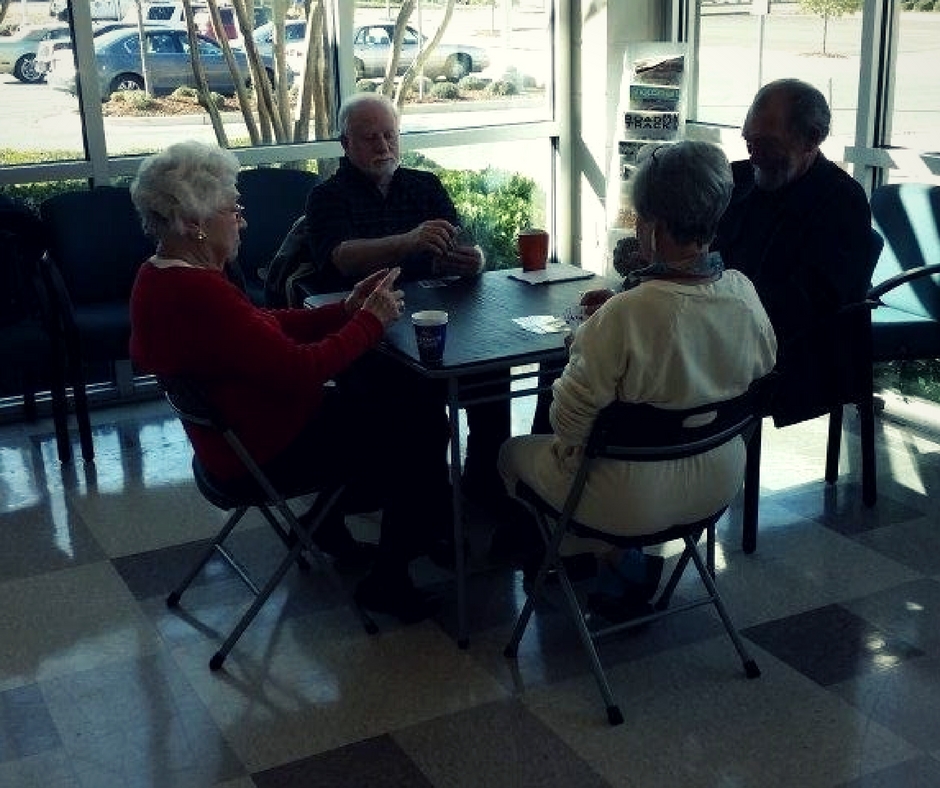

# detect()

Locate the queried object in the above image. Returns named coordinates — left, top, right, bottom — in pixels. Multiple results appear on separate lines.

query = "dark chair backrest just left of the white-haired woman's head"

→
left=39, top=186, right=154, bottom=305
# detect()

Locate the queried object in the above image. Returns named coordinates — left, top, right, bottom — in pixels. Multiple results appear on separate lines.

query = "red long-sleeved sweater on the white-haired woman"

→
left=130, top=263, right=383, bottom=479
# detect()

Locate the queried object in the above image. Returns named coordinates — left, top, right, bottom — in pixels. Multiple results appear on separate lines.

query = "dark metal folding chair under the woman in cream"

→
left=504, top=378, right=768, bottom=725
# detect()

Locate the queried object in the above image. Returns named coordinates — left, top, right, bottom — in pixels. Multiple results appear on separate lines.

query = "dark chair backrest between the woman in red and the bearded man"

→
left=238, top=167, right=319, bottom=303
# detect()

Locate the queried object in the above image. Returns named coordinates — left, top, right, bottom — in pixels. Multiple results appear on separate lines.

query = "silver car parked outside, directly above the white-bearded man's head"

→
left=253, top=20, right=490, bottom=82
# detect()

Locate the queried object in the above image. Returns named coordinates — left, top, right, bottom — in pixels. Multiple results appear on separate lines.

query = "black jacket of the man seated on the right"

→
left=712, top=154, right=871, bottom=426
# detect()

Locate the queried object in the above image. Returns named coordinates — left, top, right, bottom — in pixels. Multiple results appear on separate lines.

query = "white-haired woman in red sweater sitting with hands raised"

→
left=130, top=142, right=440, bottom=622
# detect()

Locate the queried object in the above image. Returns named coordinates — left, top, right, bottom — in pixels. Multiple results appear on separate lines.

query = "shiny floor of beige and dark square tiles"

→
left=0, top=390, right=940, bottom=788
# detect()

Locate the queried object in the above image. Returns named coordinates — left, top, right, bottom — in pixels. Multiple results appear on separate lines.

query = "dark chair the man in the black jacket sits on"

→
left=741, top=229, right=884, bottom=553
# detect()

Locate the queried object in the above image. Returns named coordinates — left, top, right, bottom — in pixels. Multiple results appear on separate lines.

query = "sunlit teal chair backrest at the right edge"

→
left=871, top=183, right=940, bottom=320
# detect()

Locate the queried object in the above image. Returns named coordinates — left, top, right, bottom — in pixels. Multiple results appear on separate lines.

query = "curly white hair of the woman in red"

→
left=131, top=141, right=241, bottom=238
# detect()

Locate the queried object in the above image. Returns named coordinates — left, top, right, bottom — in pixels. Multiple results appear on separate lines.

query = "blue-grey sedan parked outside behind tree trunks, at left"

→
left=48, top=25, right=293, bottom=100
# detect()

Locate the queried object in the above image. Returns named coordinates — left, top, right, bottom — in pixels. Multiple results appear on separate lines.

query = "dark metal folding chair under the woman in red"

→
left=159, top=378, right=378, bottom=670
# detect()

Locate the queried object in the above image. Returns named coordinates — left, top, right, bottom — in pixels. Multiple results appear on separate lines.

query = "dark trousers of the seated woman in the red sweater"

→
left=250, top=354, right=453, bottom=574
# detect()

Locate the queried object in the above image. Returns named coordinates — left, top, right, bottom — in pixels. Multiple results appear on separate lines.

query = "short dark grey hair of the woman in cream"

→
left=630, top=140, right=734, bottom=245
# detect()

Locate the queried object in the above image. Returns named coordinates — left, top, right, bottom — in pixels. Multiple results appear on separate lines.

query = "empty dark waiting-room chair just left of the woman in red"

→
left=39, top=186, right=154, bottom=460
